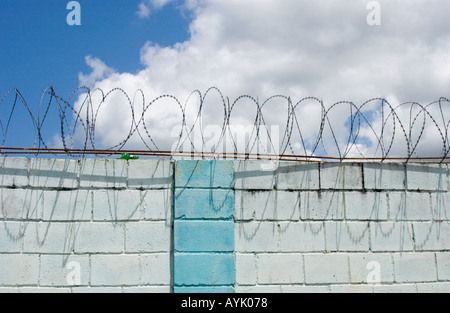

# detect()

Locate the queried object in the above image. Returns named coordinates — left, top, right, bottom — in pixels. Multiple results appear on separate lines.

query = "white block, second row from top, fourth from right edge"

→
left=300, top=191, right=344, bottom=220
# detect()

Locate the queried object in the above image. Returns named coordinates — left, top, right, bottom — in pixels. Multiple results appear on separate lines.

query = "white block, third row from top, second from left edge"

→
left=23, top=222, right=77, bottom=254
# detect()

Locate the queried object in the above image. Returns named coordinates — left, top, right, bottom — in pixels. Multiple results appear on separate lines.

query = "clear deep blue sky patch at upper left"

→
left=0, top=0, right=189, bottom=100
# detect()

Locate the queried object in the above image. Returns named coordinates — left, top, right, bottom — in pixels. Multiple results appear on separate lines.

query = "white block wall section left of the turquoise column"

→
left=0, top=158, right=173, bottom=292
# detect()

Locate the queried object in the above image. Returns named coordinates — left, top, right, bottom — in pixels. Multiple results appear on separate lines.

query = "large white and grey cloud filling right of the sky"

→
left=75, top=0, right=450, bottom=157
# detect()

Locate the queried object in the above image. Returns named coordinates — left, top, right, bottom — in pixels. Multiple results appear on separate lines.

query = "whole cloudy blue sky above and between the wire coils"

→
left=0, top=0, right=450, bottom=154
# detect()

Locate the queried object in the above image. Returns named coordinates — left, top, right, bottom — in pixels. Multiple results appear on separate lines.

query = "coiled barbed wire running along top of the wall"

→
left=0, top=87, right=450, bottom=163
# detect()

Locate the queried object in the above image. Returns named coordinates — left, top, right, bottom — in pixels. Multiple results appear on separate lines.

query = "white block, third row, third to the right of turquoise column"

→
left=325, top=221, right=370, bottom=251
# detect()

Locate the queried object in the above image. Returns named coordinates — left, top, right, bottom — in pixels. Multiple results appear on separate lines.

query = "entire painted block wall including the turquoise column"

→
left=0, top=157, right=450, bottom=293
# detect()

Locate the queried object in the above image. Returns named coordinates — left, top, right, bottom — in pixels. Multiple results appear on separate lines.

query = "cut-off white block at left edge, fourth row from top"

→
left=0, top=254, right=39, bottom=287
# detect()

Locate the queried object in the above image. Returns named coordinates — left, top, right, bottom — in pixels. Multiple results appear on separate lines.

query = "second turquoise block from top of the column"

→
left=175, top=189, right=234, bottom=219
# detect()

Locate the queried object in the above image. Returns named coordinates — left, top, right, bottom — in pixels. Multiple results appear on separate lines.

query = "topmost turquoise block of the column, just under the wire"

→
left=175, top=160, right=234, bottom=188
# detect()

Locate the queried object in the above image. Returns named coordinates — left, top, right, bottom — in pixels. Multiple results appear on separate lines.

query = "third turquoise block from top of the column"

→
left=174, top=220, right=234, bottom=252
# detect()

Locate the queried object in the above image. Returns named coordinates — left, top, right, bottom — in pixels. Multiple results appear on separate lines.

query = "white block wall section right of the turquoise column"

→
left=235, top=162, right=450, bottom=293
